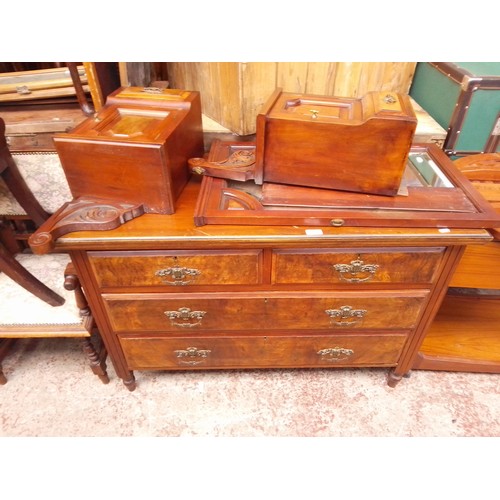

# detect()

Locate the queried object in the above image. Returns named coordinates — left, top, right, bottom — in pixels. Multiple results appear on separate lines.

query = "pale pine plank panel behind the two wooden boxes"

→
left=166, top=62, right=416, bottom=135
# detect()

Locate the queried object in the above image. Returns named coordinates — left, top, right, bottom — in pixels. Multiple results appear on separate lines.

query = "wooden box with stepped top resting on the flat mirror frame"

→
left=255, top=89, right=417, bottom=196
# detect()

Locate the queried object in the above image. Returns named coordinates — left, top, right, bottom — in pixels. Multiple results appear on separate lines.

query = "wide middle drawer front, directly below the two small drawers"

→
left=103, top=290, right=428, bottom=334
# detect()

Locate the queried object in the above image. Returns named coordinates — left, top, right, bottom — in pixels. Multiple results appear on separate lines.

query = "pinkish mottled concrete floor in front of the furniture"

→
left=0, top=339, right=500, bottom=437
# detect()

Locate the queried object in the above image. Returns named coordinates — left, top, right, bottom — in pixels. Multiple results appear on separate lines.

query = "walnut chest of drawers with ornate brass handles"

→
left=28, top=179, right=491, bottom=390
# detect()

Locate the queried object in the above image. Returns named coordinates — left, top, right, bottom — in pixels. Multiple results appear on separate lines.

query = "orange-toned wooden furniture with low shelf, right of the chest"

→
left=414, top=153, right=500, bottom=373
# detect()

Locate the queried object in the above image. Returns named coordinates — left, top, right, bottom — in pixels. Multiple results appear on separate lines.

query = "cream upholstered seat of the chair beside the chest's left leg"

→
left=0, top=253, right=85, bottom=338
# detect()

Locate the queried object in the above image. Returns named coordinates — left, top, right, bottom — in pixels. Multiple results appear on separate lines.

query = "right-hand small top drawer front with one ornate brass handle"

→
left=272, top=248, right=444, bottom=285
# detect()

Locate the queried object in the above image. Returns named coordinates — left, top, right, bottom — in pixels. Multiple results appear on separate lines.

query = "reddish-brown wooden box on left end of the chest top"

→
left=54, top=88, right=204, bottom=214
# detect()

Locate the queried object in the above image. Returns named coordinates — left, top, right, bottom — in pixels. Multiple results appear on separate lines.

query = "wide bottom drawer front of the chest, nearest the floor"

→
left=120, top=333, right=406, bottom=370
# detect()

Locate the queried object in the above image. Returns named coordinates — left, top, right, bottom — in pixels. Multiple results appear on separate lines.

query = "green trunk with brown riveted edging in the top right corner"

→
left=410, top=62, right=500, bottom=156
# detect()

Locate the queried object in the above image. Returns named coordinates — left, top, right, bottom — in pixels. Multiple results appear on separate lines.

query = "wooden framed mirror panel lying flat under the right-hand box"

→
left=194, top=141, right=500, bottom=230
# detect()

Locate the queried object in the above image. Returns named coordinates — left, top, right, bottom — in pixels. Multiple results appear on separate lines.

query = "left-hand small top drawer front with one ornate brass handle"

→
left=88, top=250, right=262, bottom=288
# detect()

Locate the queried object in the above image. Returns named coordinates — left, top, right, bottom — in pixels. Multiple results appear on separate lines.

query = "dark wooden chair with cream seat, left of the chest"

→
left=0, top=118, right=109, bottom=384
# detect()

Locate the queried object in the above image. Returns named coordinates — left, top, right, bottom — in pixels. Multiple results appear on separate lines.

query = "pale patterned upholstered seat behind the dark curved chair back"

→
left=0, top=152, right=72, bottom=216
